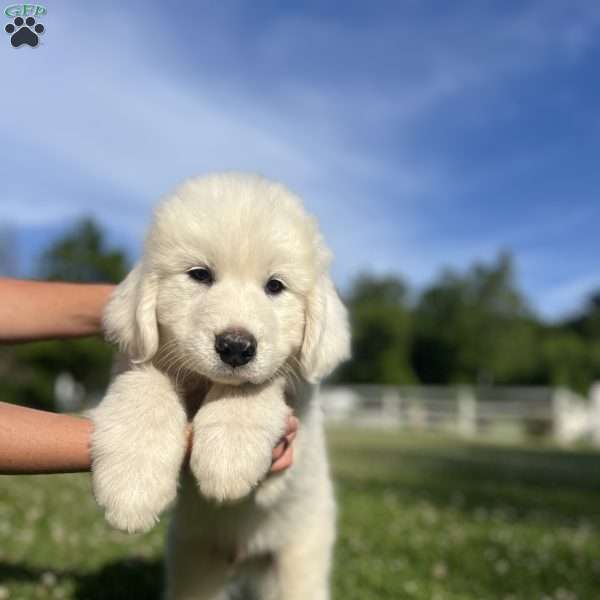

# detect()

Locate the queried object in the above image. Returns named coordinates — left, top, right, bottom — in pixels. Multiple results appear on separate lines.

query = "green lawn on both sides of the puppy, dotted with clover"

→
left=0, top=430, right=600, bottom=600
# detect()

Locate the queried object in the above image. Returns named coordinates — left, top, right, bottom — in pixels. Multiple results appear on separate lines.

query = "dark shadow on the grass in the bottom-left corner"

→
left=0, top=559, right=163, bottom=600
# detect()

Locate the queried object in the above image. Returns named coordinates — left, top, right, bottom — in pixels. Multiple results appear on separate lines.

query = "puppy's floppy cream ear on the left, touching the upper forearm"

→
left=103, top=263, right=158, bottom=363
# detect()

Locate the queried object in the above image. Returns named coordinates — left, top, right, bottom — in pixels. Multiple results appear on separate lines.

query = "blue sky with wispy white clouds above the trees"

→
left=0, top=0, right=600, bottom=318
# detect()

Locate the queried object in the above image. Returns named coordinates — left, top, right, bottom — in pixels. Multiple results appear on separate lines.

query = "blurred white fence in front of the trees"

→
left=321, top=384, right=600, bottom=445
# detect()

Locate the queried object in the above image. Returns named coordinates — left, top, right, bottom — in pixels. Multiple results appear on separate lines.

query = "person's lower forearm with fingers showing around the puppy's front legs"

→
left=0, top=402, right=298, bottom=475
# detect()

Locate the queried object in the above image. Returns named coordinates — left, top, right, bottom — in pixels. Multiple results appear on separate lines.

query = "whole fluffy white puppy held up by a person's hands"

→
left=92, top=174, right=349, bottom=600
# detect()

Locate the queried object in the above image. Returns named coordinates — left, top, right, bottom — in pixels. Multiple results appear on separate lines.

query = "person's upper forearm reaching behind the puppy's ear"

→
left=0, top=278, right=114, bottom=343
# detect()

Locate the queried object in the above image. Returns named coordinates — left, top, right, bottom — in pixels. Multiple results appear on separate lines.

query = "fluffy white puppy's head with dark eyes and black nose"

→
left=105, top=174, right=349, bottom=384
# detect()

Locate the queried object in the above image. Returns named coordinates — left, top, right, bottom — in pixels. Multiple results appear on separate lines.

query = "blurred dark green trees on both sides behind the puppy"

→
left=0, top=219, right=600, bottom=409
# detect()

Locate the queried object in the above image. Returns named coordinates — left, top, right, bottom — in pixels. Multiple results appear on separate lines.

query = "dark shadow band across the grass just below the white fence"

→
left=331, top=438, right=600, bottom=525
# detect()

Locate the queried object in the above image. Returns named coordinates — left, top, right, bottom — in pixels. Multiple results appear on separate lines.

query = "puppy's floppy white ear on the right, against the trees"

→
left=300, top=275, right=350, bottom=383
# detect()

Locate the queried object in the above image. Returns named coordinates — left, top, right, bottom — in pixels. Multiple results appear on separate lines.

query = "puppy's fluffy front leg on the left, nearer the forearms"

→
left=90, top=367, right=187, bottom=532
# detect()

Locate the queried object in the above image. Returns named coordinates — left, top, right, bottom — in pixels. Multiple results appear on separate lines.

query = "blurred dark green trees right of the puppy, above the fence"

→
left=336, top=253, right=600, bottom=393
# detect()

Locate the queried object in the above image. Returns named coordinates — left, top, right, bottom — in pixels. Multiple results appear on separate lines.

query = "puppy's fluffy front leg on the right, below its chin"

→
left=190, top=378, right=290, bottom=502
